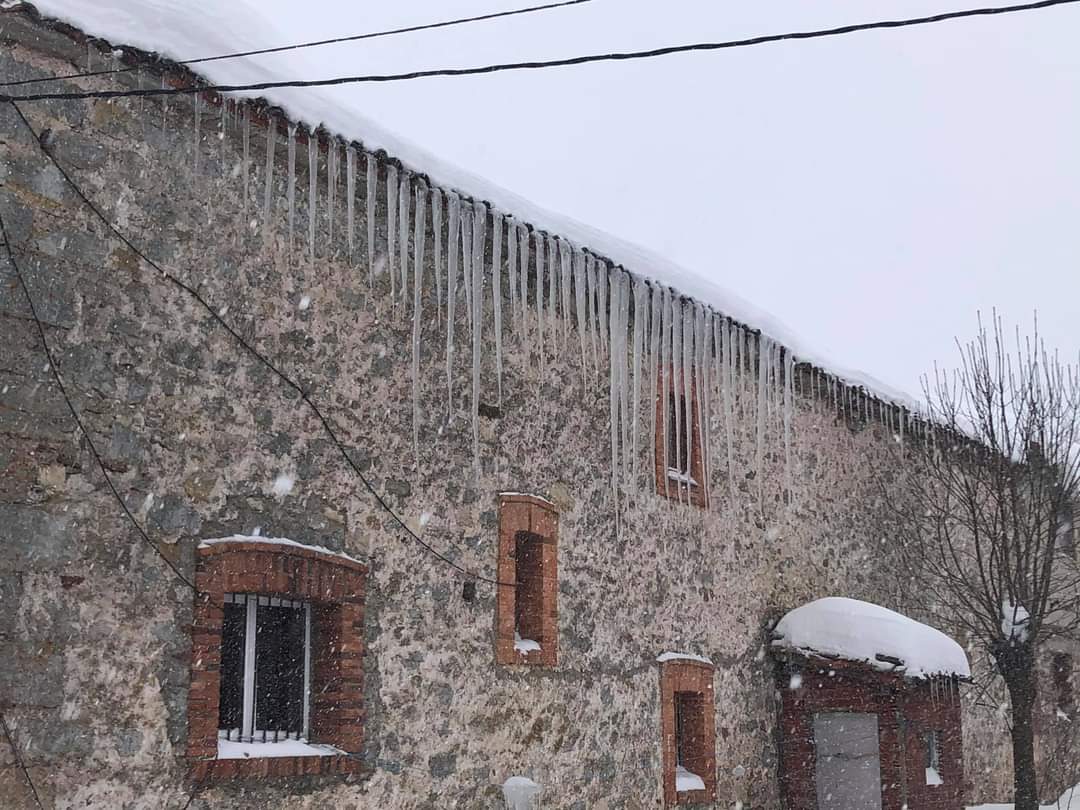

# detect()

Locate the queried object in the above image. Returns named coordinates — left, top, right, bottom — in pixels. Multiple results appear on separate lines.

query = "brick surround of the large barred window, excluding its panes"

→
left=187, top=538, right=367, bottom=781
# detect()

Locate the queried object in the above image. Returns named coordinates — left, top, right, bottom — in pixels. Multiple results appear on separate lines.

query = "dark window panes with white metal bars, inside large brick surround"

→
left=218, top=594, right=311, bottom=742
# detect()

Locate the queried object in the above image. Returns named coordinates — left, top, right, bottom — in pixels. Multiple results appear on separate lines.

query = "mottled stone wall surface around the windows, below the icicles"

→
left=0, top=7, right=1010, bottom=810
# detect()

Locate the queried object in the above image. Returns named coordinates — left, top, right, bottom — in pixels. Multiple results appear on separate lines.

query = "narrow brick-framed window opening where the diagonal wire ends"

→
left=495, top=494, right=558, bottom=666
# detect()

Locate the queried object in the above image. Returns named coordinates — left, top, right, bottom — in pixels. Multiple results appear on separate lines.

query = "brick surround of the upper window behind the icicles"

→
left=653, top=366, right=707, bottom=509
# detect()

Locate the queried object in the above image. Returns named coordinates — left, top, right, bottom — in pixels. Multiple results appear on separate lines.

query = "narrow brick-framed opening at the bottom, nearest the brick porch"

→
left=660, top=659, right=716, bottom=807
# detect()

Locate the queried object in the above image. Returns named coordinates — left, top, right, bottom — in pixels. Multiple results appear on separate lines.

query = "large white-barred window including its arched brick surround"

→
left=188, top=537, right=367, bottom=780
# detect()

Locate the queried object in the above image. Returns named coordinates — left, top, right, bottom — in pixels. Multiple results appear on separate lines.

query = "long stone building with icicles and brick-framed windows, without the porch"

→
left=0, top=6, right=1008, bottom=809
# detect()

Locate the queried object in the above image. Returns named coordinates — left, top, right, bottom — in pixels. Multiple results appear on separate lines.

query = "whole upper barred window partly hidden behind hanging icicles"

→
left=656, top=369, right=705, bottom=508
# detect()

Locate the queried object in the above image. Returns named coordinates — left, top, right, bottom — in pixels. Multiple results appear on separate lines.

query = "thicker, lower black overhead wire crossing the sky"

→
left=0, top=0, right=1080, bottom=102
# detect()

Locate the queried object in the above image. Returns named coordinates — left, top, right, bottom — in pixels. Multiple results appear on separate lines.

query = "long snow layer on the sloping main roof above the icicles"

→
left=21, top=0, right=916, bottom=409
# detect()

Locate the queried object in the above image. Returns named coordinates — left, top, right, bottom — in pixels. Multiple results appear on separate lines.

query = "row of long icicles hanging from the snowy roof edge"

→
left=181, top=91, right=933, bottom=503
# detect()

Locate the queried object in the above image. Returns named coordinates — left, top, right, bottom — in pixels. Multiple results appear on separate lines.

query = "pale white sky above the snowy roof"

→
left=31, top=0, right=1080, bottom=394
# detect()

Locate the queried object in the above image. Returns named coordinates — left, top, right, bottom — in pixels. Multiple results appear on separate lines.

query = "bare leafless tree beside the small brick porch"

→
left=885, top=316, right=1080, bottom=810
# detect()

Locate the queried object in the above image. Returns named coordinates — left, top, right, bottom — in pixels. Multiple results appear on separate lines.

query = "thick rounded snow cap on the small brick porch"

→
left=772, top=596, right=971, bottom=678
